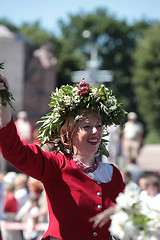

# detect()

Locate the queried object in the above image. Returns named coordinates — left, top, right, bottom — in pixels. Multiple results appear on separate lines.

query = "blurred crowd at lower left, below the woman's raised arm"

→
left=0, top=171, right=48, bottom=240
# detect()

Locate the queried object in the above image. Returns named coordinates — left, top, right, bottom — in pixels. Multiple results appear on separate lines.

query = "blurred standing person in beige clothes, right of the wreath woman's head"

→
left=122, top=112, right=144, bottom=164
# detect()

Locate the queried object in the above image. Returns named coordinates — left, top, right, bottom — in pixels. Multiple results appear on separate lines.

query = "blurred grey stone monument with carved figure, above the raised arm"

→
left=0, top=25, right=57, bottom=123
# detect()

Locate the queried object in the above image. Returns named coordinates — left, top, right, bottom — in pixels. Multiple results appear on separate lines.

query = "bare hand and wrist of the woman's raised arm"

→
left=0, top=75, right=12, bottom=128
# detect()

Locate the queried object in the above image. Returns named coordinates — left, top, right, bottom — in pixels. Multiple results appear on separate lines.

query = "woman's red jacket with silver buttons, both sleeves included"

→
left=0, top=120, right=124, bottom=240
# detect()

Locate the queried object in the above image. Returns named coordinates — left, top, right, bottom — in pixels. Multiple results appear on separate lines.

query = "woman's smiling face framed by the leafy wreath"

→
left=72, top=114, right=102, bottom=160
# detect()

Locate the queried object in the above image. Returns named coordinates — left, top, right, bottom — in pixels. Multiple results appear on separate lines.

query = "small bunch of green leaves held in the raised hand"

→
left=0, top=62, right=15, bottom=111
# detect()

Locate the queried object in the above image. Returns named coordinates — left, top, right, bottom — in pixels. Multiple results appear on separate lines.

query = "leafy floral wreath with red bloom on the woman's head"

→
left=37, top=78, right=126, bottom=156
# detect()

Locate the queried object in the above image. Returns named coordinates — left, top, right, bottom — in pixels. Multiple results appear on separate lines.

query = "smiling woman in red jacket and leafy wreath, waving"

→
left=0, top=77, right=125, bottom=240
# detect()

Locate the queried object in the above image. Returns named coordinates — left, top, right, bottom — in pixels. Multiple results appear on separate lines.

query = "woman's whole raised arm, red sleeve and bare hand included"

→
left=0, top=75, right=44, bottom=180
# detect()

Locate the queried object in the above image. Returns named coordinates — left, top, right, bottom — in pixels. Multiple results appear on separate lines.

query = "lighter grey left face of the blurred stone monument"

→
left=0, top=37, right=25, bottom=112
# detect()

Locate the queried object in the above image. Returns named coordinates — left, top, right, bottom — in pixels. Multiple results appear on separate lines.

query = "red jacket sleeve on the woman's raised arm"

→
left=0, top=118, right=56, bottom=181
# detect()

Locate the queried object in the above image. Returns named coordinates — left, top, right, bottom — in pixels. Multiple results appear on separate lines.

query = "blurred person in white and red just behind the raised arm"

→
left=15, top=111, right=34, bottom=143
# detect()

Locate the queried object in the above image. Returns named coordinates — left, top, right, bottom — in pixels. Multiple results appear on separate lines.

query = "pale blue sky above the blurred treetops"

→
left=0, top=0, right=160, bottom=32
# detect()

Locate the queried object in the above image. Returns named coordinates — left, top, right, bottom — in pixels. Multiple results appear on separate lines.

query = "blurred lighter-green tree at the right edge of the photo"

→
left=132, top=23, right=160, bottom=142
